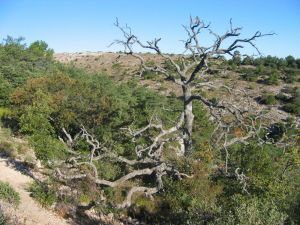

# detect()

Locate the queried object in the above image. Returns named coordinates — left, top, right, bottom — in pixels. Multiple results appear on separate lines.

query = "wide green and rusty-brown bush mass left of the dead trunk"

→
left=11, top=72, right=185, bottom=160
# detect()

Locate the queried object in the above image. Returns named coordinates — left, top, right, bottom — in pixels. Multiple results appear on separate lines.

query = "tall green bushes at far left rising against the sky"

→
left=0, top=36, right=54, bottom=106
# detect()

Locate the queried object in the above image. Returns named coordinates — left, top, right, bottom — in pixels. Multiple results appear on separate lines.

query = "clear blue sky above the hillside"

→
left=0, top=0, right=300, bottom=58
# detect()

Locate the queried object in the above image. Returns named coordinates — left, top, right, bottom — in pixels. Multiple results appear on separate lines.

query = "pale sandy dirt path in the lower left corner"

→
left=0, top=157, right=69, bottom=225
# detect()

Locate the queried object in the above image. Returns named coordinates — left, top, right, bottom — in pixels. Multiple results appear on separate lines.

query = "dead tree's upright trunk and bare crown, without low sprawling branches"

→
left=112, top=17, right=274, bottom=155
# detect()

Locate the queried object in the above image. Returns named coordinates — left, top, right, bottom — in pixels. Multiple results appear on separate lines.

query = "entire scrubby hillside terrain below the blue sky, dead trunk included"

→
left=0, top=39, right=300, bottom=225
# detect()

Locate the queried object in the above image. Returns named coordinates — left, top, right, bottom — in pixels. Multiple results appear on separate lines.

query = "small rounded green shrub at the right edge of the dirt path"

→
left=28, top=182, right=57, bottom=208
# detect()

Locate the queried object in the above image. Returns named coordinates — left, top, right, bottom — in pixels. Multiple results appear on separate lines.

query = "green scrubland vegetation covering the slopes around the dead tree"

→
left=0, top=31, right=300, bottom=224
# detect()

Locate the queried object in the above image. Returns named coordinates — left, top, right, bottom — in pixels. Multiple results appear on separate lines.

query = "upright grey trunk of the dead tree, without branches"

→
left=182, top=85, right=194, bottom=155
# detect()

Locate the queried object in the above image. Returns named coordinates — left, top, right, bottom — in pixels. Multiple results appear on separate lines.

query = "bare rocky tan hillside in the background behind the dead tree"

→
left=54, top=52, right=300, bottom=124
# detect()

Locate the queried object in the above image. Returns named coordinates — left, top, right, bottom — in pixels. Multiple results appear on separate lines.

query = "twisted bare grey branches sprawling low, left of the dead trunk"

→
left=56, top=124, right=191, bottom=208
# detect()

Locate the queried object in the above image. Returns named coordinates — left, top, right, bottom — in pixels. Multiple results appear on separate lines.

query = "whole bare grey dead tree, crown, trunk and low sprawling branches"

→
left=56, top=17, right=273, bottom=207
